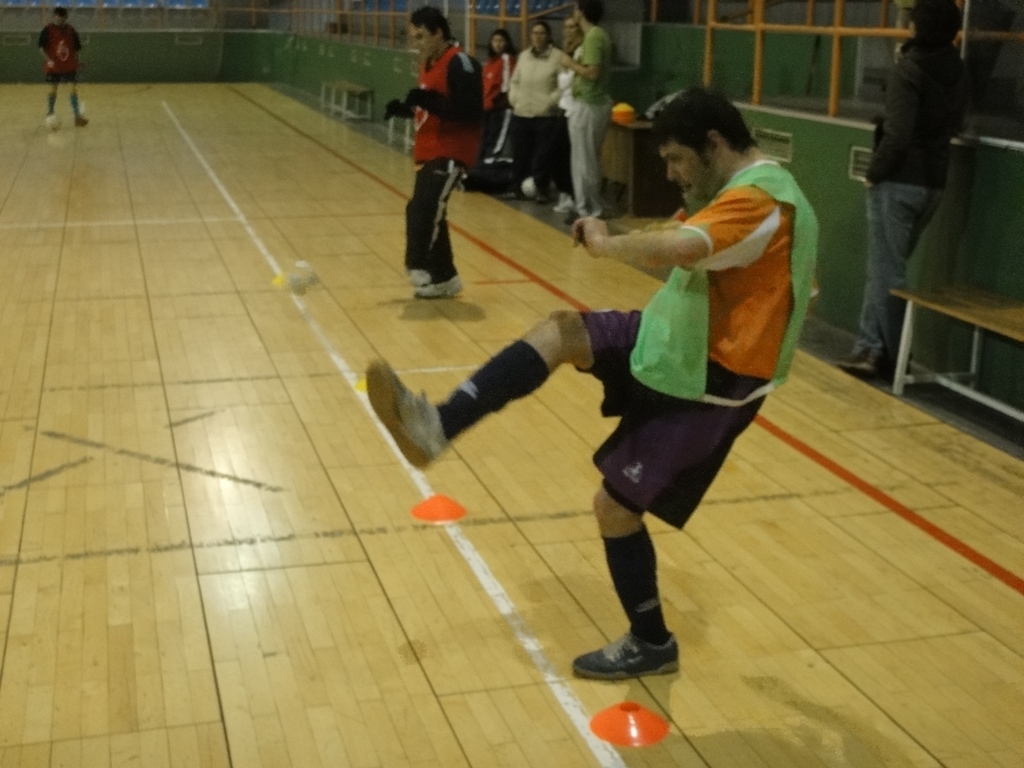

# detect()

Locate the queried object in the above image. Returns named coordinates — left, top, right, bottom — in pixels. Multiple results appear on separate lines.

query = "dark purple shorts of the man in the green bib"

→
left=583, top=311, right=765, bottom=528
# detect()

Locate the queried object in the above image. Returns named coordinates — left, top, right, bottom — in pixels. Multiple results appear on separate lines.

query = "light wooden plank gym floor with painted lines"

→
left=0, top=85, right=1024, bottom=768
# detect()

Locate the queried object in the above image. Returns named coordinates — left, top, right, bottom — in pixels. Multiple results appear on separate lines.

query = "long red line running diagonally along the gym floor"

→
left=231, top=88, right=1024, bottom=595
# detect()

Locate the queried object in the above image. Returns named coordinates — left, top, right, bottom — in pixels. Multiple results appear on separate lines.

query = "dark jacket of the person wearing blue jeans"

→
left=867, top=40, right=967, bottom=188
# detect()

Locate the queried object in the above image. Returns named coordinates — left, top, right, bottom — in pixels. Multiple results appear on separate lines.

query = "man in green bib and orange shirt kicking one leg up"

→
left=367, top=88, right=818, bottom=680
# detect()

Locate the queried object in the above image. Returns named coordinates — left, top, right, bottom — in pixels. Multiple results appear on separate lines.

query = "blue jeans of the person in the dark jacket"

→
left=853, top=181, right=942, bottom=361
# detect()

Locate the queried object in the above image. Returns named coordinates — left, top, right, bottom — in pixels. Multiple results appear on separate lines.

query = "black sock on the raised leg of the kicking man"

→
left=437, top=341, right=550, bottom=440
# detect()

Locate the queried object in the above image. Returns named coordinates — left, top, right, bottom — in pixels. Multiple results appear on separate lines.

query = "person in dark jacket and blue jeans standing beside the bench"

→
left=839, top=0, right=967, bottom=378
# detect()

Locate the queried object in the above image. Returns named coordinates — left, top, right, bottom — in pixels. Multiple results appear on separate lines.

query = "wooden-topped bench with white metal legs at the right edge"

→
left=892, top=286, right=1024, bottom=421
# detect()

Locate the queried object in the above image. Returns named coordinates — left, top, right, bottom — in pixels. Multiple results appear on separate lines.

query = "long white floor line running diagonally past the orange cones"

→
left=163, top=101, right=626, bottom=768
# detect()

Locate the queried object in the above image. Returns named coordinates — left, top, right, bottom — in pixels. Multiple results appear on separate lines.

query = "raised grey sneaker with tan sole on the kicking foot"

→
left=367, top=360, right=449, bottom=469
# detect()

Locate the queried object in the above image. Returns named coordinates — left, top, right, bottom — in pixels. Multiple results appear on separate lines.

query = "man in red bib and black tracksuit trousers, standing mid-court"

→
left=384, top=6, right=483, bottom=299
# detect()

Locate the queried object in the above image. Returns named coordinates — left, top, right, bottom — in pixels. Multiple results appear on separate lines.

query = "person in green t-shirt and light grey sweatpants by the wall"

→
left=562, top=0, right=611, bottom=220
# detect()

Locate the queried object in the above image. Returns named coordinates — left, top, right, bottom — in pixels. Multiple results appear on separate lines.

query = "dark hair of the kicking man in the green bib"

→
left=651, top=86, right=757, bottom=153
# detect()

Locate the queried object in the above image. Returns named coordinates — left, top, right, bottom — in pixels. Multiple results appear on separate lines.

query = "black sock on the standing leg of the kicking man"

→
left=604, top=527, right=671, bottom=645
